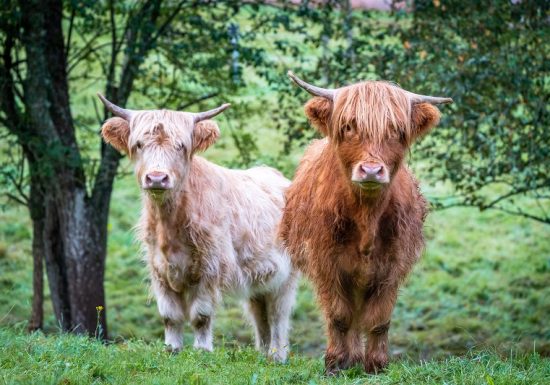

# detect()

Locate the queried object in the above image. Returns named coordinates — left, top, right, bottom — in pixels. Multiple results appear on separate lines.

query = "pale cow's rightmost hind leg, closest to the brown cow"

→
left=266, top=273, right=298, bottom=362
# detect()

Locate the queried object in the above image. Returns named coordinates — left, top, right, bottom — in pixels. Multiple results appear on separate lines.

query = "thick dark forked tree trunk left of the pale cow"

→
left=20, top=0, right=111, bottom=338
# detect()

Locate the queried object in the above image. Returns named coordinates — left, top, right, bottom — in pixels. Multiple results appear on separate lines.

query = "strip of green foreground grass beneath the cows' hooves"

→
left=0, top=328, right=550, bottom=385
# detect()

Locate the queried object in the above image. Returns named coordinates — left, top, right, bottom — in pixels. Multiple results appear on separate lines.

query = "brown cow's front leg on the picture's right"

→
left=363, top=287, right=397, bottom=373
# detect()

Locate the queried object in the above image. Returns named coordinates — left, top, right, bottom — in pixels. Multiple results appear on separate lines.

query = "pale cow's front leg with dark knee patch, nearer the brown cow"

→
left=189, top=287, right=218, bottom=352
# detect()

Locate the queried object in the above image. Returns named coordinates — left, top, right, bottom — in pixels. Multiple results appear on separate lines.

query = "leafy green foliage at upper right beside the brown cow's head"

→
left=386, top=0, right=550, bottom=223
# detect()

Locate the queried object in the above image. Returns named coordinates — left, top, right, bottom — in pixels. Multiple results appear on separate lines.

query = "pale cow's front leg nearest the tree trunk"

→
left=152, top=277, right=184, bottom=352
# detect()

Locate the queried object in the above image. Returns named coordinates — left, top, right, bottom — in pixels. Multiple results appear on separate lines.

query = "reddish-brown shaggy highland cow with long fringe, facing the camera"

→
left=280, top=72, right=452, bottom=374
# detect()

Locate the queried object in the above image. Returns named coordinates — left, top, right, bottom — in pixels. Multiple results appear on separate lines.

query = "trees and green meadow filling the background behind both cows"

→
left=0, top=0, right=550, bottom=382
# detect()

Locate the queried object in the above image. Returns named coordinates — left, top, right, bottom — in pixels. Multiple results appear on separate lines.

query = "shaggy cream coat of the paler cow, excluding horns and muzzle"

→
left=102, top=110, right=298, bottom=361
